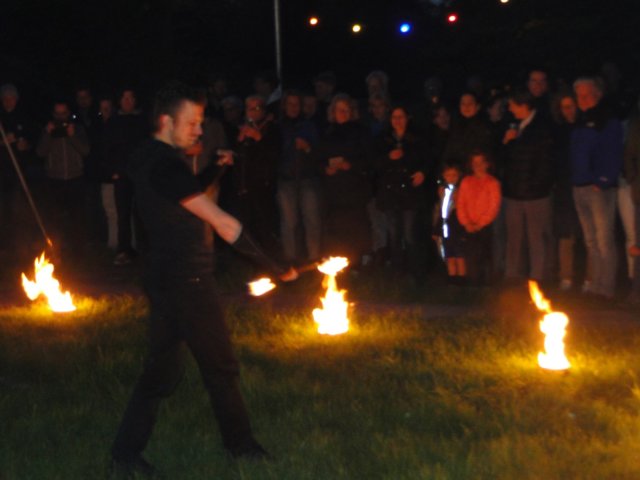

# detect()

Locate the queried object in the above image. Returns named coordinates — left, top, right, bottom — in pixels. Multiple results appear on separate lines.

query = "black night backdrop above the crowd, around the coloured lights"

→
left=0, top=0, right=640, bottom=109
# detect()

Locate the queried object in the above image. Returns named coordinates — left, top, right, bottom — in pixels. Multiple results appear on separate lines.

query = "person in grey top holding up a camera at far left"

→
left=36, top=100, right=90, bottom=260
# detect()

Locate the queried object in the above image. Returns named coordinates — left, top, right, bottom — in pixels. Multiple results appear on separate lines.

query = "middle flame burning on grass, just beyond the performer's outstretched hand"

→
left=313, top=257, right=349, bottom=335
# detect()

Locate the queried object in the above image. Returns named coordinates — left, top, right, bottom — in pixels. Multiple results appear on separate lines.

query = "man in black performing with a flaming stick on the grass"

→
left=111, top=83, right=297, bottom=475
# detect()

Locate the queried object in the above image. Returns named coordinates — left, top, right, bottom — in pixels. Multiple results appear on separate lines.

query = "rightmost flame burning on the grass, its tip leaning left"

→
left=529, top=280, right=571, bottom=370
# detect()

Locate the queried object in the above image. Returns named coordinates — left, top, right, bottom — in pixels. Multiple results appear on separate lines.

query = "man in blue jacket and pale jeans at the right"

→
left=571, top=77, right=623, bottom=299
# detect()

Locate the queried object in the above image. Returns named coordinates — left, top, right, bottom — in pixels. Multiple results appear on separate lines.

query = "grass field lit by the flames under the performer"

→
left=0, top=272, right=640, bottom=480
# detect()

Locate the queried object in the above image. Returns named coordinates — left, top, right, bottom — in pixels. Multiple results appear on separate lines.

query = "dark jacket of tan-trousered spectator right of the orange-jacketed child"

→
left=502, top=112, right=553, bottom=200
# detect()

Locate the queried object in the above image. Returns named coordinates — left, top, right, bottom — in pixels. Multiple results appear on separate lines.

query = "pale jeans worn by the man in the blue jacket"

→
left=573, top=185, right=618, bottom=297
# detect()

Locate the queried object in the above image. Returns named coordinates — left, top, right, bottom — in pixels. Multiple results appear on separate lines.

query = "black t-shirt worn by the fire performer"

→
left=129, top=139, right=213, bottom=277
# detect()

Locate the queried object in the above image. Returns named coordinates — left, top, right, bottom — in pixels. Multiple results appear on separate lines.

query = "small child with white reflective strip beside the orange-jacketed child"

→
left=433, top=163, right=466, bottom=285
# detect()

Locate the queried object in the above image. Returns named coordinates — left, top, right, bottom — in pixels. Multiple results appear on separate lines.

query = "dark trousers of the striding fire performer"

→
left=112, top=276, right=252, bottom=460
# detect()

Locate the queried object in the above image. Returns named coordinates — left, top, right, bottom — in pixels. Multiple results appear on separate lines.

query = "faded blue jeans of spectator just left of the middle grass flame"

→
left=277, top=179, right=322, bottom=261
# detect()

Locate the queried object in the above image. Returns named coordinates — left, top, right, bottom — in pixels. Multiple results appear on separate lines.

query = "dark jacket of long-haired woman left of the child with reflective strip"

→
left=374, top=130, right=427, bottom=210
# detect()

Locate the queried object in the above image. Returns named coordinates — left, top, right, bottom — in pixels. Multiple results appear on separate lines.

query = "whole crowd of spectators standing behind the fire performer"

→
left=0, top=63, right=640, bottom=302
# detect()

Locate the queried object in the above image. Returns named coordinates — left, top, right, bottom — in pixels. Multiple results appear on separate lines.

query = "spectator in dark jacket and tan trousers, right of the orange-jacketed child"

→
left=502, top=90, right=553, bottom=281
